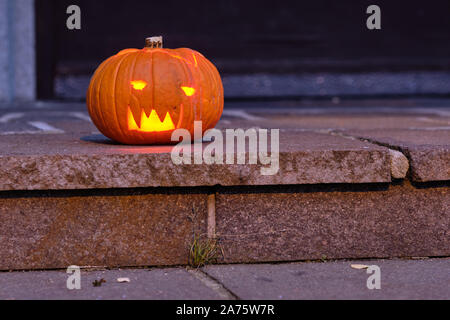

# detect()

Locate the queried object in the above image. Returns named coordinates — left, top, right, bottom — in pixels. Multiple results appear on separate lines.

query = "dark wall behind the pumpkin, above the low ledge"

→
left=36, top=0, right=450, bottom=96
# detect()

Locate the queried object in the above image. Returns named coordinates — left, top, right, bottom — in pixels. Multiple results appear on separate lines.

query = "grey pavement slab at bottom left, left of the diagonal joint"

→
left=0, top=268, right=221, bottom=300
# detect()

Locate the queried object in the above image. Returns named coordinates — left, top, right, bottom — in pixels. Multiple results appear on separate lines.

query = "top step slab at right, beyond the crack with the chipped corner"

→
left=220, top=103, right=450, bottom=182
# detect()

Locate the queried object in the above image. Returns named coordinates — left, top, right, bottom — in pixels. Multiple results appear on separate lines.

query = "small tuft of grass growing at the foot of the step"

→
left=188, top=236, right=221, bottom=268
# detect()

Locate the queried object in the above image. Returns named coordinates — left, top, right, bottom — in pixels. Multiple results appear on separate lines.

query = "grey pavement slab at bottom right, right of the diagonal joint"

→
left=204, top=259, right=450, bottom=300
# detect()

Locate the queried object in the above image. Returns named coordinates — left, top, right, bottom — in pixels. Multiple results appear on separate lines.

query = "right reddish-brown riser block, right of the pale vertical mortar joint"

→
left=216, top=182, right=450, bottom=263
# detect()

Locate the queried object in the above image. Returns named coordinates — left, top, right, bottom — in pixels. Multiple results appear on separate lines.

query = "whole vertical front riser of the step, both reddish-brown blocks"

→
left=0, top=182, right=450, bottom=270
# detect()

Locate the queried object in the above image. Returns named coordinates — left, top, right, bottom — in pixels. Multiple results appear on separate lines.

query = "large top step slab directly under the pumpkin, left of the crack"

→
left=0, top=106, right=391, bottom=191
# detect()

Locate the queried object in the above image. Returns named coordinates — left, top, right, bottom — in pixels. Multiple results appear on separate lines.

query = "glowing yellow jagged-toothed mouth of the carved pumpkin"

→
left=128, top=107, right=175, bottom=132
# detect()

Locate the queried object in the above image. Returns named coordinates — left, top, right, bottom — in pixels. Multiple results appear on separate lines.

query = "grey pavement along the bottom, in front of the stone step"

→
left=0, top=258, right=450, bottom=300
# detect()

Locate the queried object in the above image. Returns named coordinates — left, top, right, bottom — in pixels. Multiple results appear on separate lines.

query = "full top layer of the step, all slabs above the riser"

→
left=0, top=102, right=450, bottom=190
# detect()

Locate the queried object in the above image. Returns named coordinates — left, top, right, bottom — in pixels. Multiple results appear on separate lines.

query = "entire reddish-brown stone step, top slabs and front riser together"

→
left=0, top=100, right=450, bottom=270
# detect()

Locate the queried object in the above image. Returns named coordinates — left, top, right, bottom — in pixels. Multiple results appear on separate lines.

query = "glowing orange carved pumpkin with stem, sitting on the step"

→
left=87, top=37, right=223, bottom=144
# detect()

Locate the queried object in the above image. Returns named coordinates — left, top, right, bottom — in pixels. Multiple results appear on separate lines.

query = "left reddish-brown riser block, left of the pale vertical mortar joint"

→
left=0, top=190, right=207, bottom=270
